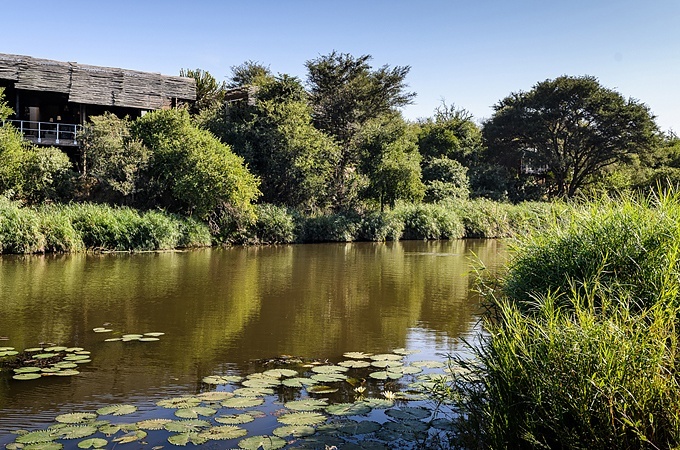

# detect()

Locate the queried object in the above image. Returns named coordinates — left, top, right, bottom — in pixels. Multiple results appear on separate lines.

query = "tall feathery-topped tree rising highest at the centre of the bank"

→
left=305, top=51, right=415, bottom=208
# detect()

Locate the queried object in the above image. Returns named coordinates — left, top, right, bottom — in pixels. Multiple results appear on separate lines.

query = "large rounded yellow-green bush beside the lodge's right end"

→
left=132, top=110, right=259, bottom=219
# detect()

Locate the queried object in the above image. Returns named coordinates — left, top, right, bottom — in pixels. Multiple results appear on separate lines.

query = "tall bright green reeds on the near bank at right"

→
left=440, top=194, right=680, bottom=449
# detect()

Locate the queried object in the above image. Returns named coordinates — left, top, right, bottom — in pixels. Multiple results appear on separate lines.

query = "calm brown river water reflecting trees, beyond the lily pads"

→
left=0, top=240, right=505, bottom=444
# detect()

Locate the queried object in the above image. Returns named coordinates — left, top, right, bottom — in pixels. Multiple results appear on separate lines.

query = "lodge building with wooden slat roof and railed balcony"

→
left=0, top=53, right=196, bottom=147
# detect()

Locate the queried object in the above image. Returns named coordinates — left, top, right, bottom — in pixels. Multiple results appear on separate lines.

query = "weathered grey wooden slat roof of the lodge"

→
left=0, top=53, right=196, bottom=109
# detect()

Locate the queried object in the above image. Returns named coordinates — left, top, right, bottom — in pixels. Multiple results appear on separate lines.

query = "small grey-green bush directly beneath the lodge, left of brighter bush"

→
left=80, top=113, right=151, bottom=204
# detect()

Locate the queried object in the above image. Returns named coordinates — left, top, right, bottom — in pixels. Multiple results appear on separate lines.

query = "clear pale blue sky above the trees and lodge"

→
left=5, top=0, right=680, bottom=132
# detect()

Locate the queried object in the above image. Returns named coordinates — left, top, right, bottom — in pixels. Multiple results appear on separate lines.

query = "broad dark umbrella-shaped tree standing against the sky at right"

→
left=482, top=76, right=657, bottom=197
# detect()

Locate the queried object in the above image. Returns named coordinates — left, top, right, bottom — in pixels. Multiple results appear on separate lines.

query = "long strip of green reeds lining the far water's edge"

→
left=0, top=198, right=567, bottom=254
